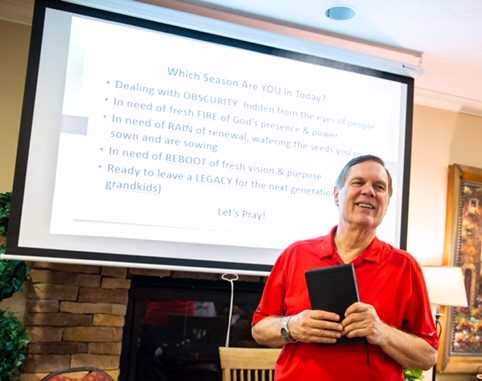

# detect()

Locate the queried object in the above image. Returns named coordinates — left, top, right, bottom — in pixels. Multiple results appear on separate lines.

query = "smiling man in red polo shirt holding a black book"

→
left=252, top=155, right=438, bottom=381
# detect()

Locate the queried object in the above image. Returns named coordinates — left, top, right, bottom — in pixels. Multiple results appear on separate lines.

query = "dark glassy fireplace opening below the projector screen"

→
left=119, top=276, right=264, bottom=381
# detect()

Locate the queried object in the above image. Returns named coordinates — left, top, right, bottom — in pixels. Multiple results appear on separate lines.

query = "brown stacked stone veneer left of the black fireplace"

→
left=21, top=262, right=259, bottom=381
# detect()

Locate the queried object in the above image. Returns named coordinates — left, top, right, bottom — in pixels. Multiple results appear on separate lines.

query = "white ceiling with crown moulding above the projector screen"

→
left=0, top=0, right=482, bottom=116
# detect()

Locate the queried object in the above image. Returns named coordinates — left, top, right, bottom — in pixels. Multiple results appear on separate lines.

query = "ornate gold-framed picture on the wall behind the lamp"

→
left=437, top=164, right=482, bottom=374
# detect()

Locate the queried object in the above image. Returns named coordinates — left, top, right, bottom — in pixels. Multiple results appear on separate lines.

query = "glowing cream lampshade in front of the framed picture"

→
left=422, top=266, right=467, bottom=307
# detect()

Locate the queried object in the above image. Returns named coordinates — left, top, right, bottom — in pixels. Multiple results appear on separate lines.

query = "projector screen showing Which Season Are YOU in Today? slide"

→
left=5, top=1, right=413, bottom=274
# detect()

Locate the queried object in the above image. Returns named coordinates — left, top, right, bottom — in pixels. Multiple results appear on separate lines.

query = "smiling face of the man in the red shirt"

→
left=334, top=160, right=390, bottom=229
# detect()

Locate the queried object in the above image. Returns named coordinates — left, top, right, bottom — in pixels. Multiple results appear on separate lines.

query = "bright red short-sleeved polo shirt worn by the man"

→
left=253, top=227, right=438, bottom=381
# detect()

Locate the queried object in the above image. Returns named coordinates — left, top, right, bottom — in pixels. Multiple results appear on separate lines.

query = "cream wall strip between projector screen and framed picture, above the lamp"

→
left=407, top=106, right=458, bottom=266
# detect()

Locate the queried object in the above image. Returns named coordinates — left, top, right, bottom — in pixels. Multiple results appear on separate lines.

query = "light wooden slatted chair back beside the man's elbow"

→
left=219, top=347, right=281, bottom=381
